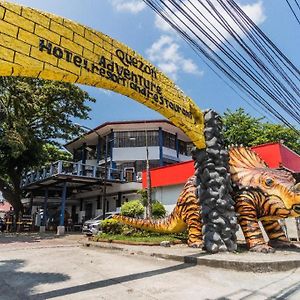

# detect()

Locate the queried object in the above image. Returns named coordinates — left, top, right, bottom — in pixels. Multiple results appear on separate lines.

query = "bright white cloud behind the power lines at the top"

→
left=155, top=0, right=266, bottom=49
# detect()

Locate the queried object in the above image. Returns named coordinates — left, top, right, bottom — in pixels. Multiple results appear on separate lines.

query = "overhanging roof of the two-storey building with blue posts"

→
left=65, top=119, right=190, bottom=151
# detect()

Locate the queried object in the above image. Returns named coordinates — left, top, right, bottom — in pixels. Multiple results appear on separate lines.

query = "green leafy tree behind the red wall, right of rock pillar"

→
left=222, top=108, right=300, bottom=154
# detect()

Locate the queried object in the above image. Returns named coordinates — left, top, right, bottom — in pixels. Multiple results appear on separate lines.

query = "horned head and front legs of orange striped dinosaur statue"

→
left=229, top=147, right=300, bottom=252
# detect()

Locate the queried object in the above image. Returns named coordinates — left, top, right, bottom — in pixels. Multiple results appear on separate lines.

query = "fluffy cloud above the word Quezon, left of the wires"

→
left=146, top=35, right=203, bottom=80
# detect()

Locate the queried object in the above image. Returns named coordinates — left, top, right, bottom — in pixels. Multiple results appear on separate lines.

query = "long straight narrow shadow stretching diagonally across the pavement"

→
left=30, top=263, right=194, bottom=300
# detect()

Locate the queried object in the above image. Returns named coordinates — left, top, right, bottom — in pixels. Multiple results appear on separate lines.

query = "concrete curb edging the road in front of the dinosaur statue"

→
left=80, top=241, right=300, bottom=273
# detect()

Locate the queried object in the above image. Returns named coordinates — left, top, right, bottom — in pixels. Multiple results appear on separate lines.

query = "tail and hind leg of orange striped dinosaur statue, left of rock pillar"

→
left=113, top=176, right=202, bottom=247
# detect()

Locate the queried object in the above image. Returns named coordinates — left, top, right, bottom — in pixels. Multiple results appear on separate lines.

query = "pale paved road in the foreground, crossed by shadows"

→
left=0, top=236, right=300, bottom=300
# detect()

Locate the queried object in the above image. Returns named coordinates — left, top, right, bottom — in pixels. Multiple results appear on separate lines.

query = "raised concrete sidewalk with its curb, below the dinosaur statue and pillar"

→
left=80, top=241, right=300, bottom=272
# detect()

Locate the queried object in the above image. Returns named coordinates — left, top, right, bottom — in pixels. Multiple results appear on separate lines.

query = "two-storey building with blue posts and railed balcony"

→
left=23, top=120, right=192, bottom=233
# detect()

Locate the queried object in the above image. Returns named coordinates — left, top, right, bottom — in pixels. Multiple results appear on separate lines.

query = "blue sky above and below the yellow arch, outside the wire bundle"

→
left=6, top=0, right=300, bottom=127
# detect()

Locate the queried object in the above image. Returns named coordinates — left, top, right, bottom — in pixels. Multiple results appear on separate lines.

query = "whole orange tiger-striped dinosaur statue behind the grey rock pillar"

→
left=114, top=146, right=300, bottom=253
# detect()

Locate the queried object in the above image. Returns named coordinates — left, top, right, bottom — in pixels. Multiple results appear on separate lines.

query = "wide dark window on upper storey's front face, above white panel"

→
left=114, top=130, right=159, bottom=148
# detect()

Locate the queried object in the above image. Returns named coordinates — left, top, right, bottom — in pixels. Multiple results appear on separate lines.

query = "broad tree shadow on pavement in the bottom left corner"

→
left=0, top=259, right=70, bottom=300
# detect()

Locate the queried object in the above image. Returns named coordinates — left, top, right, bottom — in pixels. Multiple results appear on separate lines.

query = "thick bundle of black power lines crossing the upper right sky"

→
left=144, top=0, right=300, bottom=131
